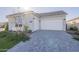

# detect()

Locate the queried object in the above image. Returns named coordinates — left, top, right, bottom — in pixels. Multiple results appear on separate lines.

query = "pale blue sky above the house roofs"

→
left=0, top=7, right=79, bottom=22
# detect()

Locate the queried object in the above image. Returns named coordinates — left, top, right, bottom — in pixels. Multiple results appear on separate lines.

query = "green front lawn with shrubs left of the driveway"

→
left=0, top=31, right=29, bottom=52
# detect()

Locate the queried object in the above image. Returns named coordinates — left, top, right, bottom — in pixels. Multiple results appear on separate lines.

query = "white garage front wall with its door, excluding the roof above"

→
left=40, top=16, right=66, bottom=31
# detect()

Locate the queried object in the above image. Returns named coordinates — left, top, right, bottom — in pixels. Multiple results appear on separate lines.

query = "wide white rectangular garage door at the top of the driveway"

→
left=41, top=19, right=64, bottom=30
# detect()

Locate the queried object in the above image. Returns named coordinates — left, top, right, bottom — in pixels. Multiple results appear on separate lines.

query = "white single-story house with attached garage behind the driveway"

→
left=7, top=11, right=67, bottom=31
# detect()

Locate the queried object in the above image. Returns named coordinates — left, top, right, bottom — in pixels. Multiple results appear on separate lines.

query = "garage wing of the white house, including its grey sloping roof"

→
left=34, top=11, right=67, bottom=31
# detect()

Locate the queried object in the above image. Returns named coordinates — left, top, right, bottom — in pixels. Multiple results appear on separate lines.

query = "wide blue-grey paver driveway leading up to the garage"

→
left=8, top=30, right=79, bottom=52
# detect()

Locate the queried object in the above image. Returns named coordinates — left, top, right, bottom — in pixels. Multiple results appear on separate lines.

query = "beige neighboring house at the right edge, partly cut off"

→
left=67, top=17, right=79, bottom=29
